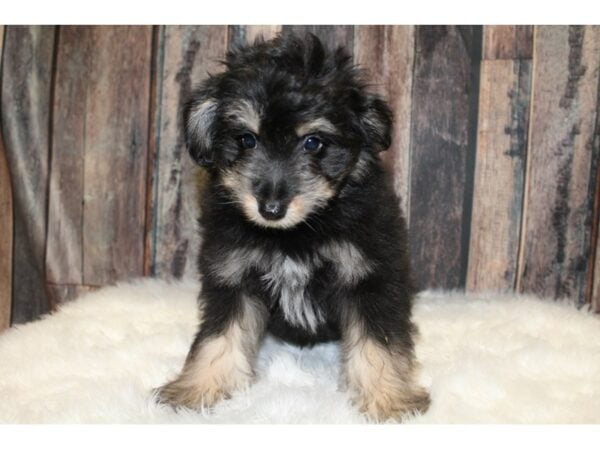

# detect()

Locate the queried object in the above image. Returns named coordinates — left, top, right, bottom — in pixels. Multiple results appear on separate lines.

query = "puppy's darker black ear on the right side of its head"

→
left=361, top=95, right=393, bottom=153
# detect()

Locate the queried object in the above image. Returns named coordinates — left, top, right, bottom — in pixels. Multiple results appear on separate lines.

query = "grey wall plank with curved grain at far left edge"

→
left=1, top=26, right=55, bottom=323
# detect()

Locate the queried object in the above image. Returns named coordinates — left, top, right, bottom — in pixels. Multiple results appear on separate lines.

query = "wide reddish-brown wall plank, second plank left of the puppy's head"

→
left=81, top=26, right=152, bottom=285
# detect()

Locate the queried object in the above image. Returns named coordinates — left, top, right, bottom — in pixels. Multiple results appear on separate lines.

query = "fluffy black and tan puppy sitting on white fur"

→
left=159, top=35, right=429, bottom=421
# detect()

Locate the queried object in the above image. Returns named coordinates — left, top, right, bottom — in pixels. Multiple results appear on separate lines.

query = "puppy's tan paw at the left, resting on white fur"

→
left=155, top=377, right=230, bottom=409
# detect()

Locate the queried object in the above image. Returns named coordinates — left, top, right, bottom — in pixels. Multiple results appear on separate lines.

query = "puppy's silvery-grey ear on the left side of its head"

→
left=183, top=90, right=217, bottom=168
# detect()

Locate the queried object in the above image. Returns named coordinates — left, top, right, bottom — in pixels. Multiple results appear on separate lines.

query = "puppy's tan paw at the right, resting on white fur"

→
left=352, top=387, right=430, bottom=422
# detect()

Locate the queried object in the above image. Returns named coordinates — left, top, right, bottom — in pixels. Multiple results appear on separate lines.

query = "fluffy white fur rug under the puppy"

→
left=0, top=279, right=600, bottom=423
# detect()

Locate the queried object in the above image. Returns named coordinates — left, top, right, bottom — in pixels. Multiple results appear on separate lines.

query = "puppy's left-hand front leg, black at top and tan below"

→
left=158, top=286, right=267, bottom=408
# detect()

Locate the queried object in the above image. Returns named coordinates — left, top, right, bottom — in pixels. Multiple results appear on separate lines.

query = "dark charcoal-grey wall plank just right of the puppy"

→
left=409, top=26, right=481, bottom=288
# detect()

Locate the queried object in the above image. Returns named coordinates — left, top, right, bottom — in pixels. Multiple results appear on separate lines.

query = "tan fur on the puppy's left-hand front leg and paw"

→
left=159, top=299, right=266, bottom=408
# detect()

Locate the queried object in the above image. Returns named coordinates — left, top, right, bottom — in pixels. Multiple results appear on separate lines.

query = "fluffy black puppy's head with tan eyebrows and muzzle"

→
left=184, top=35, right=392, bottom=228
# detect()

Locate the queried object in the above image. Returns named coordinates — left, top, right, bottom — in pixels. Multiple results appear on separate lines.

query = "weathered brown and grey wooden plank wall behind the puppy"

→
left=0, top=25, right=600, bottom=326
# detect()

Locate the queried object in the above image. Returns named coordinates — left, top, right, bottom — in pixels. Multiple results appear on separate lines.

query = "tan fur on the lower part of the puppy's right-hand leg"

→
left=343, top=325, right=429, bottom=421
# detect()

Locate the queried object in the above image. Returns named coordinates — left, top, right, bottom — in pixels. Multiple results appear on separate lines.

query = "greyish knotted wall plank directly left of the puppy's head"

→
left=150, top=26, right=227, bottom=277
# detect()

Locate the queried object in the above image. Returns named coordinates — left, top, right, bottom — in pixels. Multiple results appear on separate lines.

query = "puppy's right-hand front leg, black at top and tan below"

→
left=342, top=284, right=429, bottom=421
